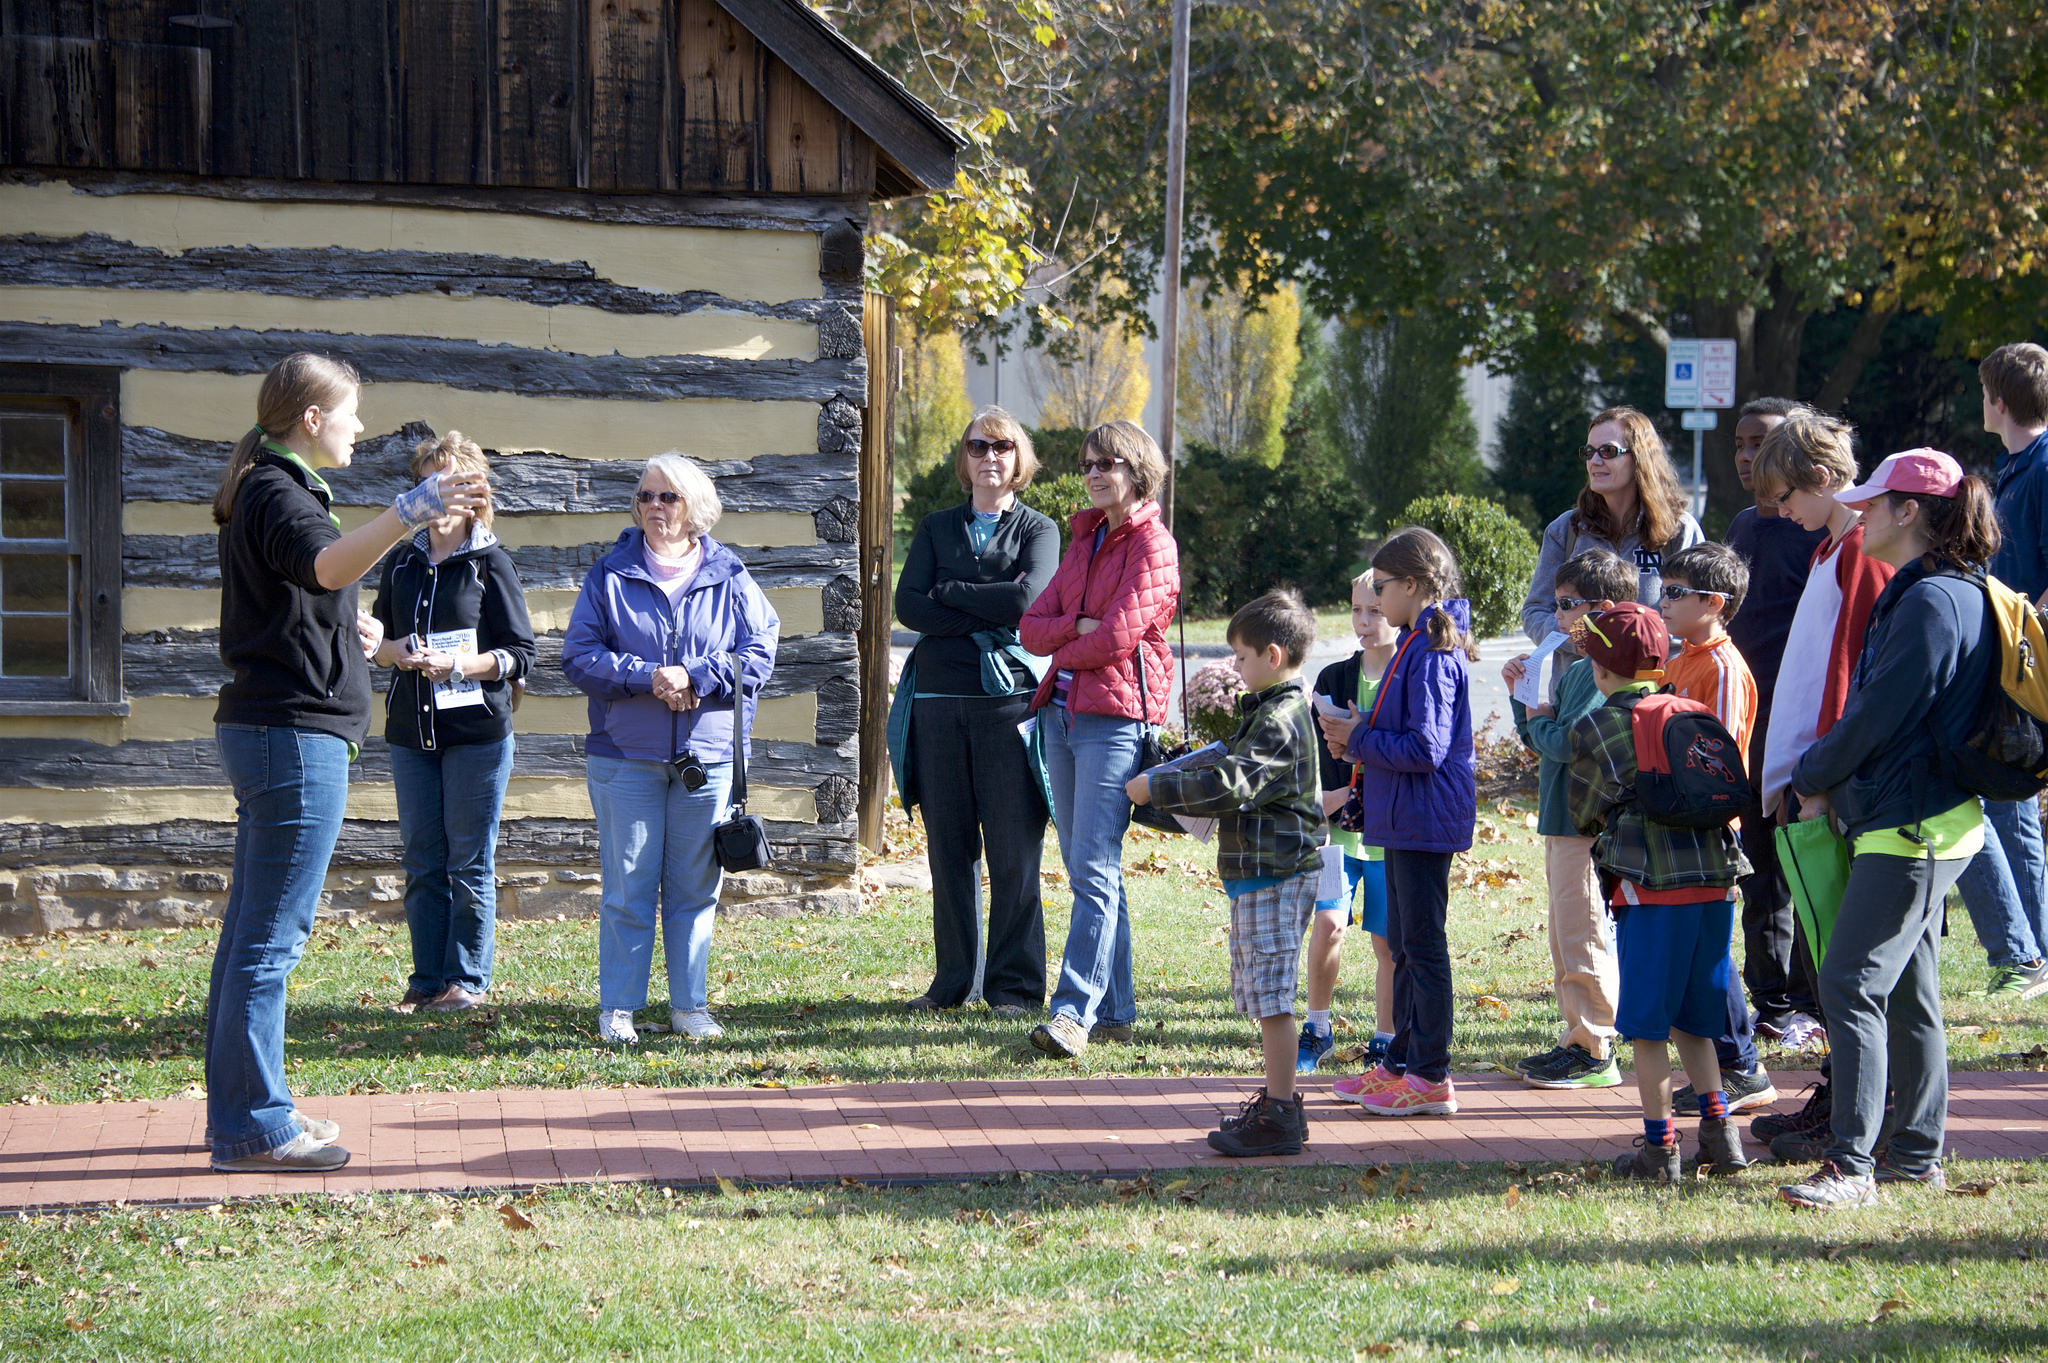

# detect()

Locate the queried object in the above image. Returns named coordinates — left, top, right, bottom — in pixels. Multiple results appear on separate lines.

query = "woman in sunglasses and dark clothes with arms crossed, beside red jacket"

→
left=895, top=407, right=1059, bottom=1017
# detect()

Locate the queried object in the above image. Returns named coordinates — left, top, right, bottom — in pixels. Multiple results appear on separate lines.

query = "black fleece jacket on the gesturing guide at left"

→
left=213, top=450, right=371, bottom=743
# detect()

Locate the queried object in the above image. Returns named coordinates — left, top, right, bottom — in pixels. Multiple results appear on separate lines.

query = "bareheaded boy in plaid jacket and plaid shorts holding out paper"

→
left=1124, top=591, right=1325, bottom=1156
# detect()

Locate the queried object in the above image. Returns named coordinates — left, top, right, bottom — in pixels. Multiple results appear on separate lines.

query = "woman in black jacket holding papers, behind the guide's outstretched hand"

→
left=375, top=430, right=535, bottom=1013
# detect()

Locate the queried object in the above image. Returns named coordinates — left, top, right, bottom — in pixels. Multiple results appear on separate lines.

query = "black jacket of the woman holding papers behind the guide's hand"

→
left=371, top=526, right=535, bottom=751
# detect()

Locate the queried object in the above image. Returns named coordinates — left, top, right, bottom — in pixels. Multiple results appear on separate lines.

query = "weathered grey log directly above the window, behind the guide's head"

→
left=0, top=321, right=868, bottom=403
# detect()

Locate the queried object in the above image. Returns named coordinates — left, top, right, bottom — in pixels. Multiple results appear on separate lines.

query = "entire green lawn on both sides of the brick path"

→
left=0, top=804, right=2048, bottom=1363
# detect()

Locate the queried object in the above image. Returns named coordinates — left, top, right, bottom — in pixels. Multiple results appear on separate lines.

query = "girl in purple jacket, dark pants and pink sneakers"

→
left=1321, top=526, right=1479, bottom=1117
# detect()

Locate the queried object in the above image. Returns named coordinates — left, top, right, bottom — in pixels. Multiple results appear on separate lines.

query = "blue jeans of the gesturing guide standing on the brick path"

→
left=207, top=724, right=348, bottom=1160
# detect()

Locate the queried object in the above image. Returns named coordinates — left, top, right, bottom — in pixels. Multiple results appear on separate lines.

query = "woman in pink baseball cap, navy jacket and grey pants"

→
left=1780, top=450, right=1999, bottom=1210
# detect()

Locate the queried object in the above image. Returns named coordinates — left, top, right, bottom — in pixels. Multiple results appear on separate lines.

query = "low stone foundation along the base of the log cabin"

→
left=0, top=866, right=860, bottom=937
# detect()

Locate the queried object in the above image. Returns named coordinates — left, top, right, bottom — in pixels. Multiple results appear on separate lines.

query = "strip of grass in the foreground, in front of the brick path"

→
left=16, top=1164, right=2048, bottom=1363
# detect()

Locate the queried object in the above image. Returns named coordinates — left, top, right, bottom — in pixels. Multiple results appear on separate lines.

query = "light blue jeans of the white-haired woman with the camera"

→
left=586, top=753, right=733, bottom=1011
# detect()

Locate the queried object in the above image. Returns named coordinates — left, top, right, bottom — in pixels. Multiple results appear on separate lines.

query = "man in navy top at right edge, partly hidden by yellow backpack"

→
left=1958, top=342, right=2048, bottom=999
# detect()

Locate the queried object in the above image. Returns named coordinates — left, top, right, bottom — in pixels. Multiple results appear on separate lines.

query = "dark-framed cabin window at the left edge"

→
left=0, top=364, right=125, bottom=714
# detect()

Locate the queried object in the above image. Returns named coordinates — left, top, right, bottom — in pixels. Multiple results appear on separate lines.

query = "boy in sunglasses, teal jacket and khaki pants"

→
left=1501, top=548, right=1638, bottom=1089
